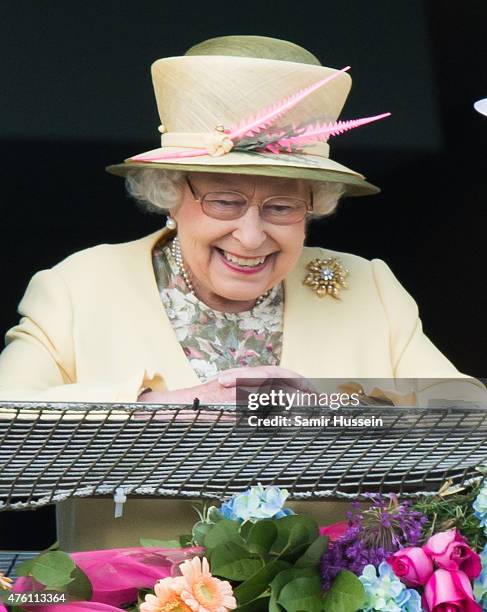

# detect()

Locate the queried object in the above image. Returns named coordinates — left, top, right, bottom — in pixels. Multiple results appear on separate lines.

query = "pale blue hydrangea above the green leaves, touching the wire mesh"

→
left=220, top=484, right=294, bottom=522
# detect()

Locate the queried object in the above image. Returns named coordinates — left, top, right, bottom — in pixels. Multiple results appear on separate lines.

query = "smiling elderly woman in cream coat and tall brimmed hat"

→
left=0, top=37, right=478, bottom=548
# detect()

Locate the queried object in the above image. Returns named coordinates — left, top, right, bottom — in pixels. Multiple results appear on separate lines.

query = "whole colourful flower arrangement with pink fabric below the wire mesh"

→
left=0, top=480, right=487, bottom=612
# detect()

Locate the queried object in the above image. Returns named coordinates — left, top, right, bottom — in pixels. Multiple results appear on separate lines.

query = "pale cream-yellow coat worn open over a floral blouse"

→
left=0, top=230, right=483, bottom=550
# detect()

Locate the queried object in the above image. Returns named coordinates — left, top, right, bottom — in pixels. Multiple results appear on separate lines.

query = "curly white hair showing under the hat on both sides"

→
left=125, top=168, right=345, bottom=218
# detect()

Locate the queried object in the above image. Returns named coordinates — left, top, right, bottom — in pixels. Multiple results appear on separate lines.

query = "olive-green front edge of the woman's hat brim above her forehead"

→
left=106, top=160, right=380, bottom=197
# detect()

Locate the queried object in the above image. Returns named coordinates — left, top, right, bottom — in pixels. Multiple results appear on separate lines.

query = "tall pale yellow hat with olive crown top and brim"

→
left=107, top=36, right=386, bottom=196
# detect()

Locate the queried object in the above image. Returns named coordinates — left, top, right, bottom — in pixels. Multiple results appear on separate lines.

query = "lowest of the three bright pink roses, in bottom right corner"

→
left=422, top=569, right=482, bottom=612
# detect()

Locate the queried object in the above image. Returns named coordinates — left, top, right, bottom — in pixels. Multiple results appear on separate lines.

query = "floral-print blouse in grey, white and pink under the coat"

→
left=152, top=244, right=284, bottom=382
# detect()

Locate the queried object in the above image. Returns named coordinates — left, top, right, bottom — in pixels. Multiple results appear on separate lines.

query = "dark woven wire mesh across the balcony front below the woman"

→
left=0, top=403, right=487, bottom=510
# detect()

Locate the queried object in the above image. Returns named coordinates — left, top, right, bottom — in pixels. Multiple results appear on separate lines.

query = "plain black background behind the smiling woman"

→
left=0, top=0, right=487, bottom=549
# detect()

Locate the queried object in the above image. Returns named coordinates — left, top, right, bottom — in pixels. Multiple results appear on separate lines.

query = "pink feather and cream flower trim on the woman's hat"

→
left=130, top=66, right=391, bottom=162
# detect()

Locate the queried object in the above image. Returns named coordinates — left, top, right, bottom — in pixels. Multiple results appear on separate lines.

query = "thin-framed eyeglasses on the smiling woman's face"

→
left=186, top=178, right=313, bottom=225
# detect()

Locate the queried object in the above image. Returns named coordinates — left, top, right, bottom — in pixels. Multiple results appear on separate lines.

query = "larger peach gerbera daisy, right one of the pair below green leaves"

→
left=181, top=557, right=237, bottom=612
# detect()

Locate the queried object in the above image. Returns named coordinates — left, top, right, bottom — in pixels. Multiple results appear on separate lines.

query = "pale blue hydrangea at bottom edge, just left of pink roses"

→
left=359, top=561, right=422, bottom=612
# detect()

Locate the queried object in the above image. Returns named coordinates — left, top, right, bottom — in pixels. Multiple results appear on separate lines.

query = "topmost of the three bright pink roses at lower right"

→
left=423, top=529, right=482, bottom=578
